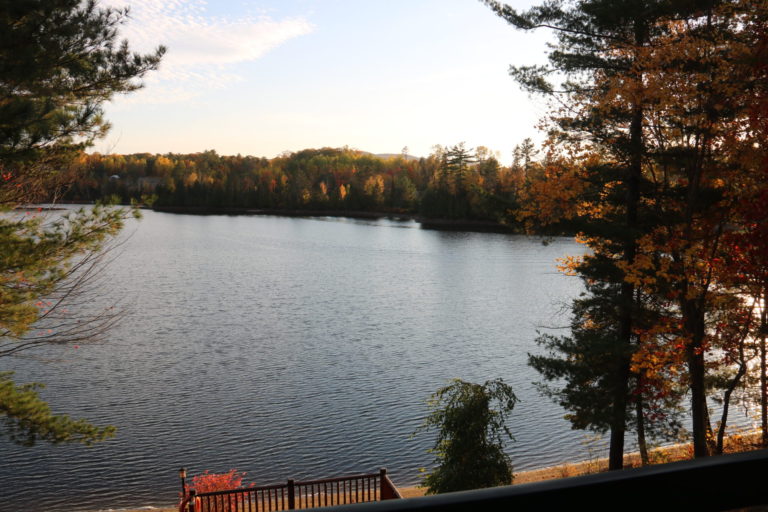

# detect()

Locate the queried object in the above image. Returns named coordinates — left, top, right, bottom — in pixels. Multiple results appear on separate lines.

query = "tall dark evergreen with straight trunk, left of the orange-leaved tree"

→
left=484, top=0, right=708, bottom=469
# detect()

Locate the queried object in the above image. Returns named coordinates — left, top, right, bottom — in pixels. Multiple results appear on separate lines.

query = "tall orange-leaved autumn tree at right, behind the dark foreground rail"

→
left=608, top=1, right=768, bottom=457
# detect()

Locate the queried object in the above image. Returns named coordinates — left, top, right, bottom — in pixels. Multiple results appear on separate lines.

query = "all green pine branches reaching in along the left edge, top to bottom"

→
left=0, top=0, right=165, bottom=444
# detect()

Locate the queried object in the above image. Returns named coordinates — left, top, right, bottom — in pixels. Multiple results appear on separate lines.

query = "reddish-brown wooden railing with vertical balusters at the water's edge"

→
left=179, top=469, right=401, bottom=512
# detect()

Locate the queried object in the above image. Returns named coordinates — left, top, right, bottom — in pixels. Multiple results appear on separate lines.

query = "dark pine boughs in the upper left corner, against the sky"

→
left=0, top=0, right=165, bottom=206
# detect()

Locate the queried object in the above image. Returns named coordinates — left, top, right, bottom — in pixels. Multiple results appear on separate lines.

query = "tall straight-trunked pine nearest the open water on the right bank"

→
left=485, top=0, right=662, bottom=469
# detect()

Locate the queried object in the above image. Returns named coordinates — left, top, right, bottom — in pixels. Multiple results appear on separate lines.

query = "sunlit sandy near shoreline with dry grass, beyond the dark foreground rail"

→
left=117, top=432, right=762, bottom=512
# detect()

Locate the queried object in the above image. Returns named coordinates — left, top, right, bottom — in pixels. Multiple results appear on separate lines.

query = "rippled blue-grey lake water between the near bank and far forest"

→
left=0, top=212, right=600, bottom=512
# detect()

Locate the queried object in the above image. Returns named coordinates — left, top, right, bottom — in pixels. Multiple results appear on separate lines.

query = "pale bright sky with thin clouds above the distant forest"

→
left=100, top=0, right=549, bottom=163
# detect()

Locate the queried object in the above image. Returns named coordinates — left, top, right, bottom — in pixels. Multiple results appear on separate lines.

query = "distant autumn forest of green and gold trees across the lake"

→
left=60, top=139, right=543, bottom=227
